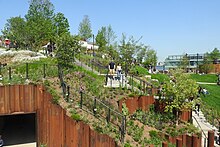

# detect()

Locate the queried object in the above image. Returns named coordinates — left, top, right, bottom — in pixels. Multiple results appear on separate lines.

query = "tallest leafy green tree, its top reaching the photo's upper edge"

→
left=25, top=0, right=55, bottom=49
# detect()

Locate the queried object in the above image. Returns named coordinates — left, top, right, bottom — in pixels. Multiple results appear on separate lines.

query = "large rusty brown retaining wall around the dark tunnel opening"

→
left=0, top=85, right=117, bottom=147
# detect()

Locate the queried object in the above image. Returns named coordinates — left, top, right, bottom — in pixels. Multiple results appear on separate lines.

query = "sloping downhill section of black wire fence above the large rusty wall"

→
left=58, top=66, right=126, bottom=142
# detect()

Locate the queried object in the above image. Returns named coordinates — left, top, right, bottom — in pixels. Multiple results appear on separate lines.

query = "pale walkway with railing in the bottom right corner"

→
left=192, top=111, right=220, bottom=147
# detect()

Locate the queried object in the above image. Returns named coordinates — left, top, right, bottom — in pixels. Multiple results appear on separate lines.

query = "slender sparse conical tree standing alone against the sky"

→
left=78, top=15, right=92, bottom=41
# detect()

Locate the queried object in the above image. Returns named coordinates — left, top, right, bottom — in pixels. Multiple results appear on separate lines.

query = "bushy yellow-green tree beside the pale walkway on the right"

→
left=164, top=69, right=198, bottom=124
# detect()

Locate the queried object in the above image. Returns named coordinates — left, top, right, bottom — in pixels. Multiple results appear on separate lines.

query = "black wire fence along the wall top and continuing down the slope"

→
left=0, top=60, right=126, bottom=142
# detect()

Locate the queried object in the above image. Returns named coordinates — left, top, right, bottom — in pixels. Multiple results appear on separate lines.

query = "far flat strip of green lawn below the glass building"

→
left=190, top=74, right=217, bottom=83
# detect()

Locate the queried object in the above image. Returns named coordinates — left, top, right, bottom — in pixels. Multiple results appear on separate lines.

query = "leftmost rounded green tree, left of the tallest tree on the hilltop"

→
left=2, top=16, right=27, bottom=47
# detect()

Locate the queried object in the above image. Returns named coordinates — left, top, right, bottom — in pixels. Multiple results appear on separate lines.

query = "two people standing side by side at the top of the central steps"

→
left=108, top=61, right=122, bottom=80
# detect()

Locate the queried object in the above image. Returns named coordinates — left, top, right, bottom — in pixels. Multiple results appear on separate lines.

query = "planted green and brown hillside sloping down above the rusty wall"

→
left=0, top=48, right=208, bottom=146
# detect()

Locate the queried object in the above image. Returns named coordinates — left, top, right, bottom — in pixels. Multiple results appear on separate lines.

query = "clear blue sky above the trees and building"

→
left=0, top=0, right=220, bottom=61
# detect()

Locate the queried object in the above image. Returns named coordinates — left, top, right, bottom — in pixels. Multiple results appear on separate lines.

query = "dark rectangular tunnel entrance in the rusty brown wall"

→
left=0, top=113, right=36, bottom=146
